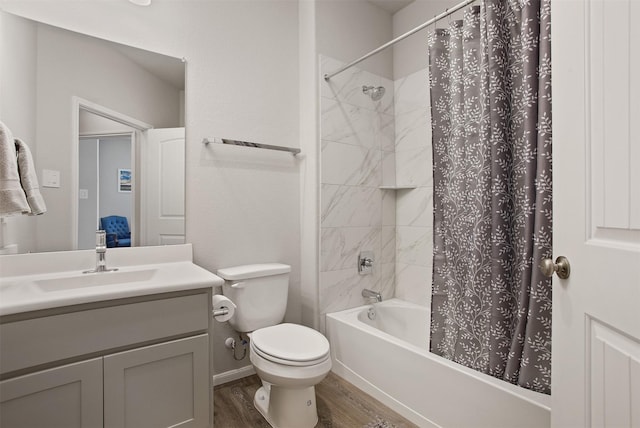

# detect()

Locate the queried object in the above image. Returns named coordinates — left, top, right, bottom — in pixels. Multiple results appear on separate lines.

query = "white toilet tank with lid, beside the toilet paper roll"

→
left=216, top=263, right=291, bottom=333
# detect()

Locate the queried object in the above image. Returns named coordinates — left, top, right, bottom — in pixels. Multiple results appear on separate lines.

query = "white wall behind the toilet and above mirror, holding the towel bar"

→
left=2, top=0, right=300, bottom=373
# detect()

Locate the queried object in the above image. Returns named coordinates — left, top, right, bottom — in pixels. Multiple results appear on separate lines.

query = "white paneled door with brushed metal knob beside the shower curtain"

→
left=551, top=0, right=640, bottom=428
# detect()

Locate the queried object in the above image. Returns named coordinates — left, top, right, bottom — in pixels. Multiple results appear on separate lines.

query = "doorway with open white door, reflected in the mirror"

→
left=75, top=104, right=185, bottom=249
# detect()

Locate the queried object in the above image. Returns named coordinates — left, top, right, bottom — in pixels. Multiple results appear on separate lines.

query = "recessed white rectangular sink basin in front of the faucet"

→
left=33, top=269, right=158, bottom=292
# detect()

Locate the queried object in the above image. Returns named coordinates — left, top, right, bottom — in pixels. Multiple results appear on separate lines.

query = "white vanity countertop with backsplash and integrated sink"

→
left=0, top=244, right=224, bottom=315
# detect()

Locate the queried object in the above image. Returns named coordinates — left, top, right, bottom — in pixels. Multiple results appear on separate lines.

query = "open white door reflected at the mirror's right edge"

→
left=140, top=128, right=185, bottom=245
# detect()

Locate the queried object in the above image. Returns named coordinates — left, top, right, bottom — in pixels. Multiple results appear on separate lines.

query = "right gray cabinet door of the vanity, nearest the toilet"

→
left=104, top=334, right=210, bottom=428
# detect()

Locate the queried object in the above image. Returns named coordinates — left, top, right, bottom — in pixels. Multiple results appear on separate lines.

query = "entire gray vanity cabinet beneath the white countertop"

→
left=0, top=288, right=212, bottom=428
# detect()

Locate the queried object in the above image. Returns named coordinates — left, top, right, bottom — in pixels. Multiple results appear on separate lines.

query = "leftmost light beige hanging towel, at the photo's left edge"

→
left=0, top=122, right=31, bottom=217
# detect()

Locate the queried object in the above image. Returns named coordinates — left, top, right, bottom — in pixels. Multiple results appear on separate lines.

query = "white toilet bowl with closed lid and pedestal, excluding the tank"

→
left=249, top=324, right=331, bottom=428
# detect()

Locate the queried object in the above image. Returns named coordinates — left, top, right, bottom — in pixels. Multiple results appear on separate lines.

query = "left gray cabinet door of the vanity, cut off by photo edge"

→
left=0, top=358, right=102, bottom=428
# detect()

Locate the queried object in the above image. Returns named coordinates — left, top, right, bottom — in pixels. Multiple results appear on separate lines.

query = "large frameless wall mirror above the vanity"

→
left=0, top=11, right=185, bottom=252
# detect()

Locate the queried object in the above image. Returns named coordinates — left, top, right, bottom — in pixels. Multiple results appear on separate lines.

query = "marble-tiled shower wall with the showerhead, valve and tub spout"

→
left=319, top=57, right=396, bottom=314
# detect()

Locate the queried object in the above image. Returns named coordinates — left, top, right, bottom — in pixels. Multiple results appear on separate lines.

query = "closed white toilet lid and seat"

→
left=251, top=323, right=329, bottom=366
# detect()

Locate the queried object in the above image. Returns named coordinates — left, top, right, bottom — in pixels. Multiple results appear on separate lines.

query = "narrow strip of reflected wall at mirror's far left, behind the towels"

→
left=0, top=13, right=37, bottom=252
